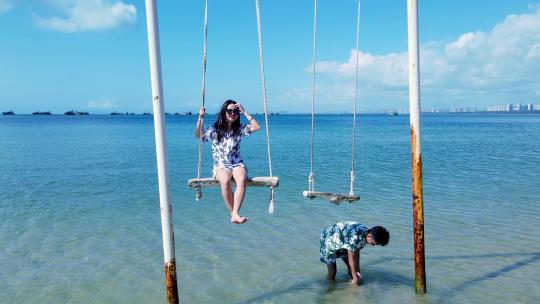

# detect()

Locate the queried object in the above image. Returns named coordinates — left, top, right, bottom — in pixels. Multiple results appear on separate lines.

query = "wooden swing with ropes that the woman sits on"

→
left=188, top=0, right=279, bottom=214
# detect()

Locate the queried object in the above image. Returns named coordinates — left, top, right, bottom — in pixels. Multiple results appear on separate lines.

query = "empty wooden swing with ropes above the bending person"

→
left=302, top=0, right=360, bottom=205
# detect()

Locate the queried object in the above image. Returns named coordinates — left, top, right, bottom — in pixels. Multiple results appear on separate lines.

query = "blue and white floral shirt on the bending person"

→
left=320, top=222, right=368, bottom=264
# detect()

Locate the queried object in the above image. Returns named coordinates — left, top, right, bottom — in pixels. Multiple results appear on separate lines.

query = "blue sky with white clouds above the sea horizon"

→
left=0, top=0, right=540, bottom=114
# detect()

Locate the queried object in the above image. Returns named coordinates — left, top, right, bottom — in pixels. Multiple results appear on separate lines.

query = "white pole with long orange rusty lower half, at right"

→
left=407, top=0, right=426, bottom=293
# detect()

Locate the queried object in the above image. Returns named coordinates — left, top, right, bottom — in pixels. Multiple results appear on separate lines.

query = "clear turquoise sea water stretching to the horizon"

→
left=0, top=115, right=540, bottom=303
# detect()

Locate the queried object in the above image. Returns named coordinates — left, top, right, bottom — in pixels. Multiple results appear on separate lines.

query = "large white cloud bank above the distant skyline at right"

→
left=300, top=5, right=540, bottom=108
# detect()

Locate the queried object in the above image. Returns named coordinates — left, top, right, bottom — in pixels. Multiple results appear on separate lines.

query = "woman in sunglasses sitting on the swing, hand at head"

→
left=195, top=100, right=260, bottom=224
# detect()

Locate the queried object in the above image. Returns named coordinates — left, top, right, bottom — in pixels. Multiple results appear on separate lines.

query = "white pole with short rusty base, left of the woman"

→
left=146, top=0, right=179, bottom=303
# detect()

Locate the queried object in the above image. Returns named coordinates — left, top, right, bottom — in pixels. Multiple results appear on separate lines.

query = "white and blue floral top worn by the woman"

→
left=202, top=124, right=251, bottom=177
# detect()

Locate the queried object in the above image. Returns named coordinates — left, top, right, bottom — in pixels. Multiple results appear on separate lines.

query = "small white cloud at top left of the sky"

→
left=35, top=0, right=137, bottom=32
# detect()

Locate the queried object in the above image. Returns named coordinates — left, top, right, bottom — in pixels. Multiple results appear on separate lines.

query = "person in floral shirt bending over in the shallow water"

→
left=320, top=222, right=390, bottom=285
